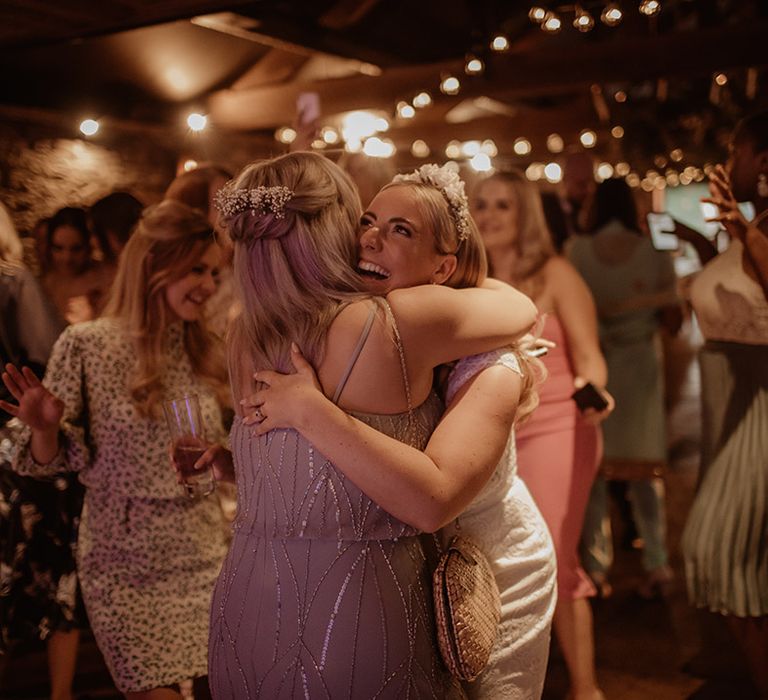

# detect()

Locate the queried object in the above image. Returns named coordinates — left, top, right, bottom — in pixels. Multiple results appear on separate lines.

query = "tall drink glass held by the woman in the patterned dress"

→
left=163, top=394, right=216, bottom=498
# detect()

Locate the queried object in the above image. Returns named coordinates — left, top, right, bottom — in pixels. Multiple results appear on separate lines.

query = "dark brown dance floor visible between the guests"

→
left=0, top=326, right=756, bottom=700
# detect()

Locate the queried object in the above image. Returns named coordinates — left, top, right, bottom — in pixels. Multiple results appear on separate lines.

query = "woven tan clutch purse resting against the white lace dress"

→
left=432, top=535, right=501, bottom=681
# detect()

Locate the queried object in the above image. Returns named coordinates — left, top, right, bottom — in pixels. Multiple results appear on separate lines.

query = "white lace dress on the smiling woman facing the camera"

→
left=443, top=349, right=557, bottom=700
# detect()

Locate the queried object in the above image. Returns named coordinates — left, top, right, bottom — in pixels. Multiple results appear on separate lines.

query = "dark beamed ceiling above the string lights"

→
left=0, top=0, right=768, bottom=168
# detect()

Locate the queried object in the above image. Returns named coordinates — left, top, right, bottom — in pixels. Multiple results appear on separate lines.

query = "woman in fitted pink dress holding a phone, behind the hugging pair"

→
left=473, top=172, right=611, bottom=700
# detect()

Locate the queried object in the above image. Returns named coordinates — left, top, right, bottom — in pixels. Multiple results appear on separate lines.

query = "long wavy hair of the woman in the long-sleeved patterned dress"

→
left=104, top=200, right=226, bottom=416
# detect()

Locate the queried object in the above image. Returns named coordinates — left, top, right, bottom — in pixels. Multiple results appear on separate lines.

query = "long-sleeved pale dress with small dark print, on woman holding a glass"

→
left=15, top=319, right=225, bottom=692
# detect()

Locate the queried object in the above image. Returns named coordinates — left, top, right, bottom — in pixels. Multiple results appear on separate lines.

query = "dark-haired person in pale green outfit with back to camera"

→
left=567, top=179, right=679, bottom=598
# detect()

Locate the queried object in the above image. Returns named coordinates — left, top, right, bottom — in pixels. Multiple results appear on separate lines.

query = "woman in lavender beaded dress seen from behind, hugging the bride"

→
left=209, top=152, right=535, bottom=699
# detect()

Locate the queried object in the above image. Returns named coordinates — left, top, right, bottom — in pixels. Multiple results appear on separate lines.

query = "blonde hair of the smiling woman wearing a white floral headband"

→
left=383, top=181, right=547, bottom=424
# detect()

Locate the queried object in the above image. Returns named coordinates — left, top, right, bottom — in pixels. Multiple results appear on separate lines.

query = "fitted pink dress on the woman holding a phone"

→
left=516, top=314, right=602, bottom=600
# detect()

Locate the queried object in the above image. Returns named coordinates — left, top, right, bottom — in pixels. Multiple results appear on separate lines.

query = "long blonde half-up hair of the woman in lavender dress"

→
left=220, top=152, right=368, bottom=393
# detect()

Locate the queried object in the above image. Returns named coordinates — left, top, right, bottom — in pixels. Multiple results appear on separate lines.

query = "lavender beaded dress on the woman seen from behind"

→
left=209, top=320, right=462, bottom=700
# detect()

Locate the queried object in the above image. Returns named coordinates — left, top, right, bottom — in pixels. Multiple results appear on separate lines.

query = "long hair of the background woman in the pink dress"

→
left=473, top=170, right=555, bottom=294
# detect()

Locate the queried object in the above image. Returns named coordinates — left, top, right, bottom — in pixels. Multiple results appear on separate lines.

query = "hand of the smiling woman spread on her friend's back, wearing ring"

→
left=240, top=344, right=328, bottom=435
